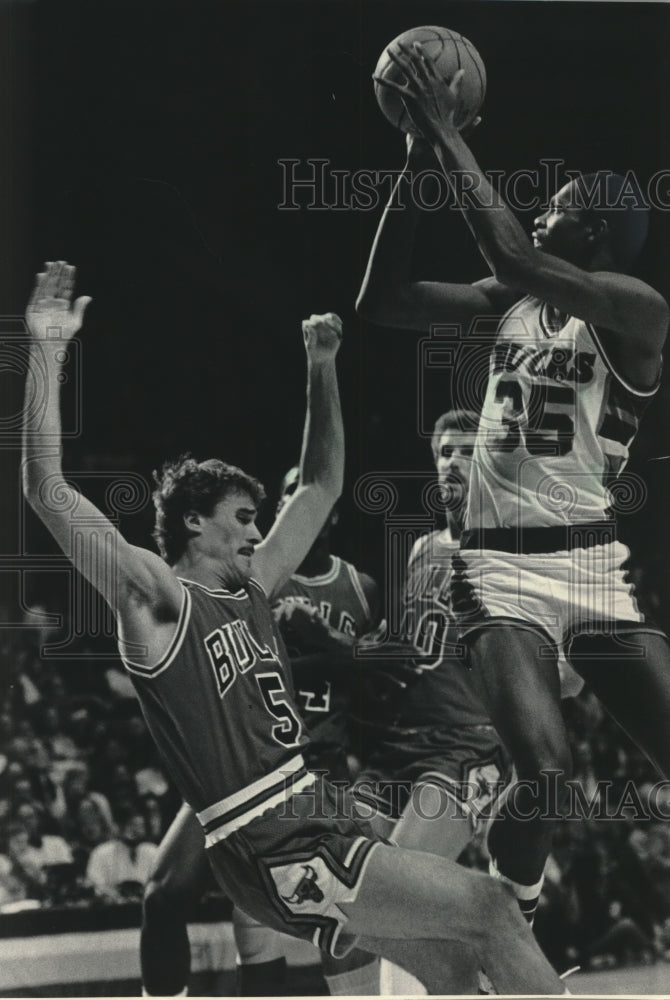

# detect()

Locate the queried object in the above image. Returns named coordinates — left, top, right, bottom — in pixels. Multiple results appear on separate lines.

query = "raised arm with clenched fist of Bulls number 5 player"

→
left=254, top=313, right=344, bottom=595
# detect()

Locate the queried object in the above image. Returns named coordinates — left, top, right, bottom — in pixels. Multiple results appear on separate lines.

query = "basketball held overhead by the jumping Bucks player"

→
left=374, top=26, right=486, bottom=132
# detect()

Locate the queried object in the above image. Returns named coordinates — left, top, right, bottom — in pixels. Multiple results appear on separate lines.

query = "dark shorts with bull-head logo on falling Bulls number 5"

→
left=202, top=775, right=388, bottom=957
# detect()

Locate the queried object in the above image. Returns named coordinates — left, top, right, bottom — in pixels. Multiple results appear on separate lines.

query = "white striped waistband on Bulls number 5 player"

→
left=196, top=754, right=316, bottom=847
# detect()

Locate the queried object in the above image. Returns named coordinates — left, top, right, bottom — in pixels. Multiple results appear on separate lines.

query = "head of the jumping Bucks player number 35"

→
left=533, top=170, right=649, bottom=271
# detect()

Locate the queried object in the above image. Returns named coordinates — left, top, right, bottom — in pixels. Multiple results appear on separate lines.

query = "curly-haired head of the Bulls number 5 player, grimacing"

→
left=153, top=455, right=265, bottom=585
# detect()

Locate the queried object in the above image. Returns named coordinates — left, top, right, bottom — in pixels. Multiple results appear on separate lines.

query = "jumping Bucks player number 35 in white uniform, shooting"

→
left=359, top=46, right=670, bottom=936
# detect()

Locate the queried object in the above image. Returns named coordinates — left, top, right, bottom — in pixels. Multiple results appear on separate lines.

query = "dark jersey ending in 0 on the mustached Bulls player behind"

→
left=396, top=529, right=490, bottom=727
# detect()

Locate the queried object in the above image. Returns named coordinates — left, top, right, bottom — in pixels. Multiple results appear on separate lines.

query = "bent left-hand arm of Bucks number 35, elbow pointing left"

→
left=356, top=130, right=520, bottom=331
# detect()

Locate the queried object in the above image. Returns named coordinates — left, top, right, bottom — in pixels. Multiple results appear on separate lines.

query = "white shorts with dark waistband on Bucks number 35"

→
left=450, top=525, right=659, bottom=697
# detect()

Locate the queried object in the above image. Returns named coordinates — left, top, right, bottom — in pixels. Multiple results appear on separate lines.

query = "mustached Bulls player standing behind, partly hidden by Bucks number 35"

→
left=357, top=410, right=511, bottom=996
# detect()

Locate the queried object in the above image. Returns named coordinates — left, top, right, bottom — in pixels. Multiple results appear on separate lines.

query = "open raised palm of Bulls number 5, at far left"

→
left=26, top=260, right=91, bottom=340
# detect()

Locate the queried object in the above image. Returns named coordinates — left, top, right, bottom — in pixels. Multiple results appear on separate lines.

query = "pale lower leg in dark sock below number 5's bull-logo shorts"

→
left=233, top=906, right=286, bottom=997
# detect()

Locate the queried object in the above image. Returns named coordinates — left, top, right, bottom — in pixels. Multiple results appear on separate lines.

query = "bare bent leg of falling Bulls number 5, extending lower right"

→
left=341, top=845, right=565, bottom=995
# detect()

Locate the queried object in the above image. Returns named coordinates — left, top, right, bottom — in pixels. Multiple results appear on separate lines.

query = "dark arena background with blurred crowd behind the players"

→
left=0, top=0, right=670, bottom=996
